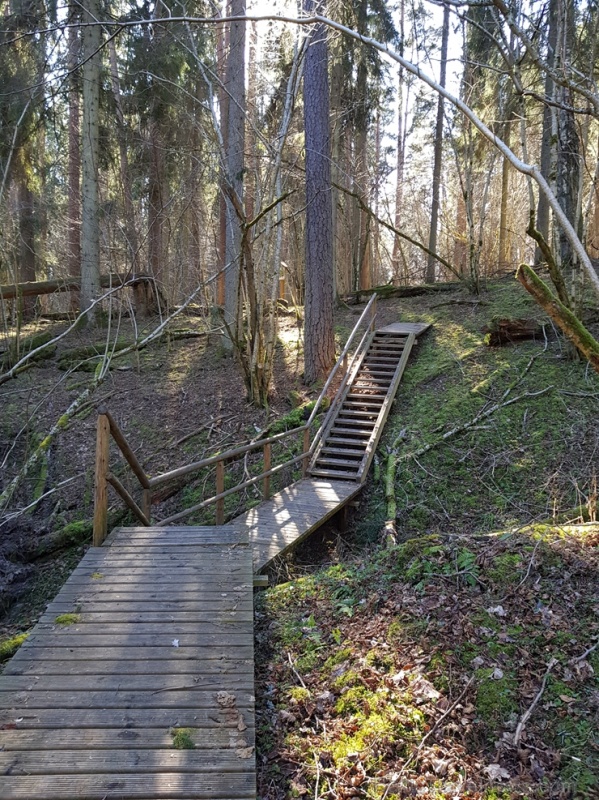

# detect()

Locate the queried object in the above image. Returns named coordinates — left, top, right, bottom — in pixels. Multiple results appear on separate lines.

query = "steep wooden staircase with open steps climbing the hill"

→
left=308, top=323, right=429, bottom=483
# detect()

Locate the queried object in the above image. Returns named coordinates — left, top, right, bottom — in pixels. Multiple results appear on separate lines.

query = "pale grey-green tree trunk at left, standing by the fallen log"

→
left=81, top=0, right=102, bottom=325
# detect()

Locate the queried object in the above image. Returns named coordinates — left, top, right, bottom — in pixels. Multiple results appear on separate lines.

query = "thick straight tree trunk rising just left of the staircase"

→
left=304, top=0, right=335, bottom=384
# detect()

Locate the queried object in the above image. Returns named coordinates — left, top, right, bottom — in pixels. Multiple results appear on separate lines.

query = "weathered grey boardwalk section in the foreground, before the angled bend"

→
left=0, top=526, right=256, bottom=800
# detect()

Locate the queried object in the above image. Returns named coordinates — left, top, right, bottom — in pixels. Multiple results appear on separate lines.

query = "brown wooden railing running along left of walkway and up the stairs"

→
left=93, top=294, right=376, bottom=546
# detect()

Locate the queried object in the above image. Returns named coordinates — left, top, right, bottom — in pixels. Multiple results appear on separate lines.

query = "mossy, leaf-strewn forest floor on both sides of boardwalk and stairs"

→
left=0, top=280, right=599, bottom=800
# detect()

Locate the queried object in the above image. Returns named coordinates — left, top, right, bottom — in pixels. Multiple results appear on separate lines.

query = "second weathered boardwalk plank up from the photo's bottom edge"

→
left=0, top=752, right=254, bottom=776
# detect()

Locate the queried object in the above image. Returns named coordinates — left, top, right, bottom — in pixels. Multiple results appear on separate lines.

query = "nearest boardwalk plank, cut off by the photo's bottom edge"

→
left=0, top=771, right=255, bottom=800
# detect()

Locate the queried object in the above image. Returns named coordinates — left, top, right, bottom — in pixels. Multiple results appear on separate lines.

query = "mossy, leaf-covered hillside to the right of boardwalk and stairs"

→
left=257, top=282, right=599, bottom=800
